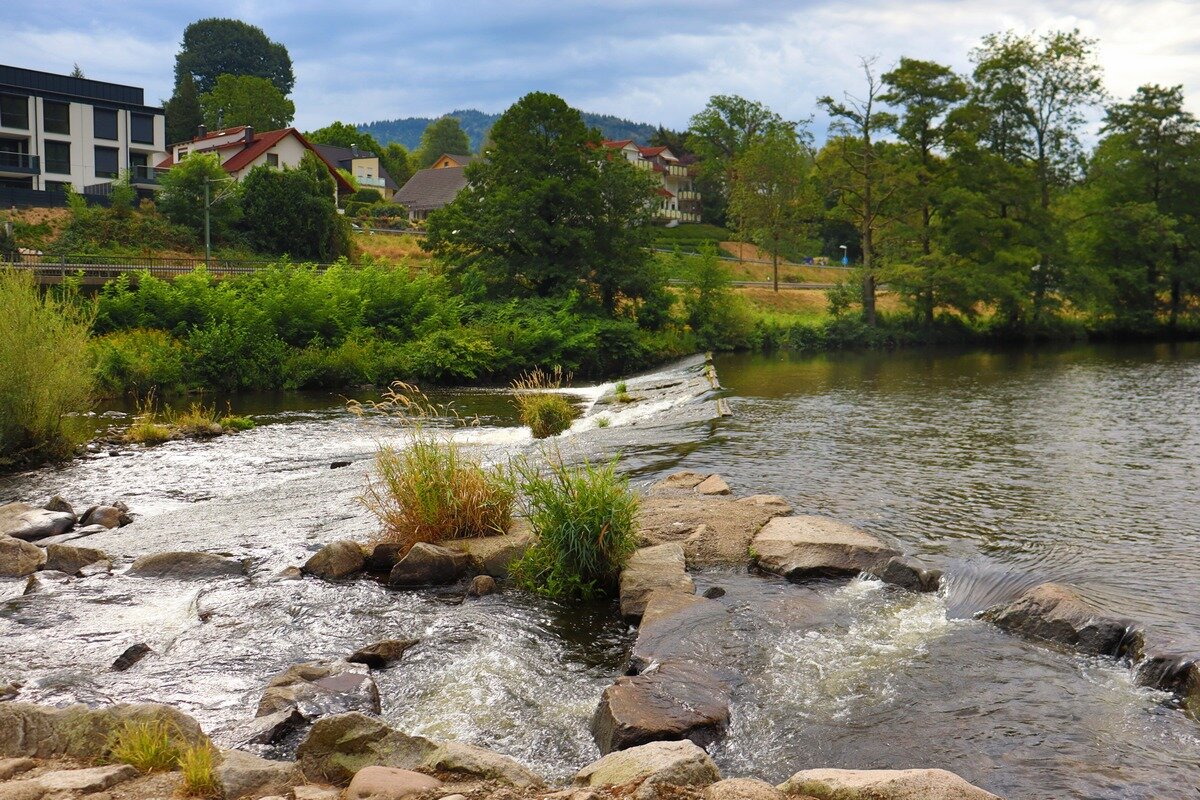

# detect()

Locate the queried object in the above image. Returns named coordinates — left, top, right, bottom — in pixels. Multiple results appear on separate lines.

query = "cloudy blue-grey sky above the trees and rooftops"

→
left=0, top=0, right=1200, bottom=137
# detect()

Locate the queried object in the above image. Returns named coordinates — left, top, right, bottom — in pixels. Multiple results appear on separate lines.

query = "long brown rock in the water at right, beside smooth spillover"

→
left=979, top=583, right=1141, bottom=656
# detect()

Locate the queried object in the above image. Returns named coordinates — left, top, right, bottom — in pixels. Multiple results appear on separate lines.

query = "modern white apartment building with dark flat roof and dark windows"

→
left=0, top=65, right=167, bottom=193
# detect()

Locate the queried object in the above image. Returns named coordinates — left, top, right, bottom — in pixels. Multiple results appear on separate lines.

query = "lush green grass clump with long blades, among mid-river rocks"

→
left=511, top=458, right=638, bottom=600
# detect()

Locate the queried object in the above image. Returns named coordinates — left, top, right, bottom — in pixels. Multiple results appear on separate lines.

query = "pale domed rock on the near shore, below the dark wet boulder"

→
left=575, top=740, right=721, bottom=788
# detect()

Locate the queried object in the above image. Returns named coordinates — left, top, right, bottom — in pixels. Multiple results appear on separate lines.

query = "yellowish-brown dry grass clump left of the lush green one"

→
left=352, top=383, right=515, bottom=552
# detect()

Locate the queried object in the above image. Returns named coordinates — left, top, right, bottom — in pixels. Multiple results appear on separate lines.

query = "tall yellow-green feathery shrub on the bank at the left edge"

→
left=0, top=269, right=92, bottom=464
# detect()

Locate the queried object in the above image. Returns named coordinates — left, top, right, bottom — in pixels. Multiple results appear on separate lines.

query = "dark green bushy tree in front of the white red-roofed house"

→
left=242, top=152, right=350, bottom=261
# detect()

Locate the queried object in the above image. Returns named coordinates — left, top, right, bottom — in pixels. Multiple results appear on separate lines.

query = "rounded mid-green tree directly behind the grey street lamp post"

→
left=156, top=152, right=241, bottom=240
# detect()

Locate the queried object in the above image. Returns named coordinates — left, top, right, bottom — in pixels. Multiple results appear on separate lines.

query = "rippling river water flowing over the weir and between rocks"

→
left=0, top=345, right=1200, bottom=799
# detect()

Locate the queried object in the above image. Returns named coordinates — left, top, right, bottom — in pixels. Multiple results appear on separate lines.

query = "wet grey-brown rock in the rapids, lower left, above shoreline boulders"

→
left=254, top=662, right=379, bottom=720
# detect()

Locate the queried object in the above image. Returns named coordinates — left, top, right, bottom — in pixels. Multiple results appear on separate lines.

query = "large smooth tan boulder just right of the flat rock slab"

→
left=750, top=516, right=900, bottom=581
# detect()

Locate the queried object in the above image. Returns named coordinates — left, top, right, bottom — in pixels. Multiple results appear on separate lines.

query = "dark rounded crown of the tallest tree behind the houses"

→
left=175, top=17, right=295, bottom=95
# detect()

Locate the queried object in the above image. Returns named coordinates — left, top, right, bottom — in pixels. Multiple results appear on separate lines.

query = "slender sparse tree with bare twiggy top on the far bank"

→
left=817, top=59, right=896, bottom=325
